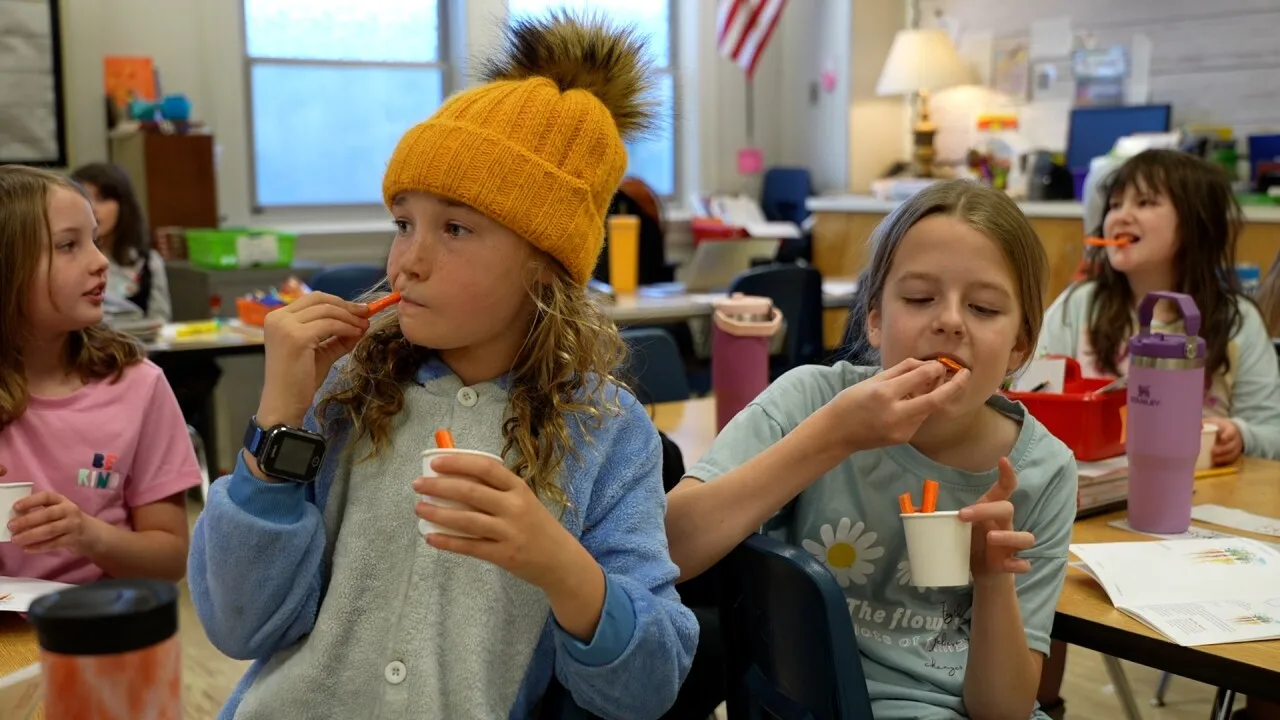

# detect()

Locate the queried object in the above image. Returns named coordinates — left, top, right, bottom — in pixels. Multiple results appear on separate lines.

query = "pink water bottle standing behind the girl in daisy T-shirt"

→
left=712, top=292, right=782, bottom=432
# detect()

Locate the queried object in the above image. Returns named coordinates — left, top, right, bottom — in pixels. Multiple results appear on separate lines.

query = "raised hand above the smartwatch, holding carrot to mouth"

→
left=257, top=292, right=369, bottom=428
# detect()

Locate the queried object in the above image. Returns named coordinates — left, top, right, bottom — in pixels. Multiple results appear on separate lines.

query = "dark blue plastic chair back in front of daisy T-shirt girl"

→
left=721, top=534, right=872, bottom=720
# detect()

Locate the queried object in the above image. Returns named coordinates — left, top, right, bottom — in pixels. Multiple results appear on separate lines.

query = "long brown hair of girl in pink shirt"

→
left=0, top=165, right=143, bottom=430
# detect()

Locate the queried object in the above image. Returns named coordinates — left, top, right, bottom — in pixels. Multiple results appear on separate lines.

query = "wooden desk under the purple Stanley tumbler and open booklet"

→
left=1053, top=459, right=1280, bottom=701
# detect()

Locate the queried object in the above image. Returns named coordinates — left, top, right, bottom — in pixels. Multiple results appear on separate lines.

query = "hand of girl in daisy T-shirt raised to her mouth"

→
left=828, top=357, right=969, bottom=452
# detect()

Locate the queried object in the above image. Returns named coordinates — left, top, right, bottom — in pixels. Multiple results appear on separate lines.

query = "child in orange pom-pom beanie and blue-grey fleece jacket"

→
left=189, top=15, right=698, bottom=720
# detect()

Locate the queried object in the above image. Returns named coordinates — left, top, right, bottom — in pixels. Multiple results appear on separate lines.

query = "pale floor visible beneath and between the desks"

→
left=180, top=502, right=1218, bottom=720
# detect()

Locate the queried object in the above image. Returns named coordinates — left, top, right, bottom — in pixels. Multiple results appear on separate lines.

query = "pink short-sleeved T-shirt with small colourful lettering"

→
left=0, top=361, right=201, bottom=584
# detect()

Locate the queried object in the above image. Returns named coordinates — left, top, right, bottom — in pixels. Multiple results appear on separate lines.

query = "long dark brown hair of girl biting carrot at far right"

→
left=1069, top=150, right=1245, bottom=382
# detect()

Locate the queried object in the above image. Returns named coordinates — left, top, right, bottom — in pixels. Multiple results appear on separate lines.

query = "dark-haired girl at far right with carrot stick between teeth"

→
left=1037, top=150, right=1280, bottom=711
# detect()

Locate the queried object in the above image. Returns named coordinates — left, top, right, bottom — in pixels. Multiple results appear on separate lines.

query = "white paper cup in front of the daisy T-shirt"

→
left=900, top=510, right=973, bottom=588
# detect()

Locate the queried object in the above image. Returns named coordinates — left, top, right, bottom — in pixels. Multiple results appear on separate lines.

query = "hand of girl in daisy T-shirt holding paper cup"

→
left=960, top=457, right=1036, bottom=578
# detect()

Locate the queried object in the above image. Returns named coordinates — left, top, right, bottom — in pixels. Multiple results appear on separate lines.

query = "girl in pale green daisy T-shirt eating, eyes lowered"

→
left=667, top=181, right=1076, bottom=720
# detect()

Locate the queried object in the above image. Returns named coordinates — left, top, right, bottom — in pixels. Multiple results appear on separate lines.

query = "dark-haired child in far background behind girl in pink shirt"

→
left=72, top=163, right=173, bottom=322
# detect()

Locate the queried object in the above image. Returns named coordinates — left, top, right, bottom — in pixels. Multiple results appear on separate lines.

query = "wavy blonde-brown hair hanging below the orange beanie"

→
left=317, top=259, right=626, bottom=510
